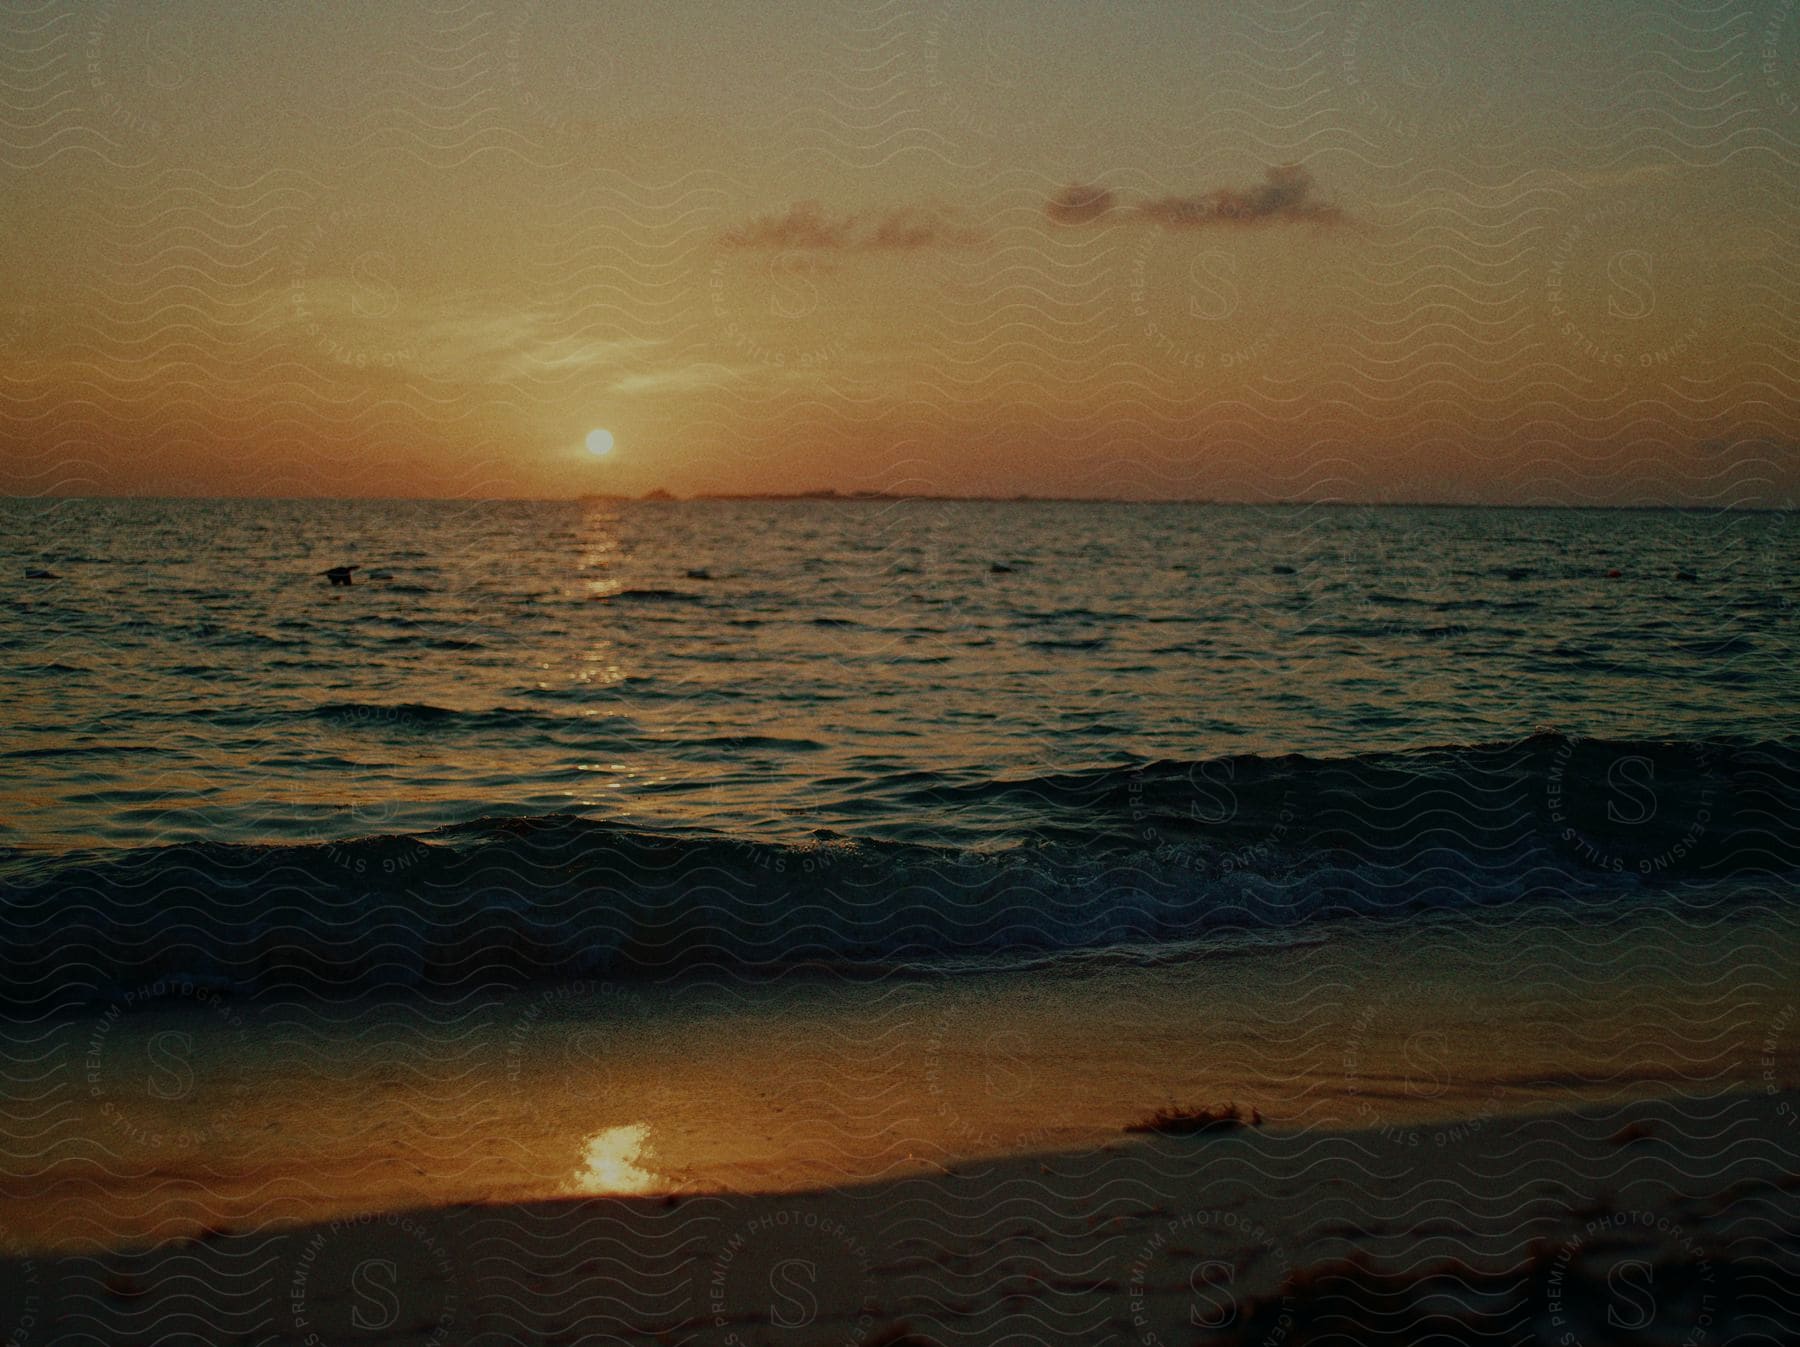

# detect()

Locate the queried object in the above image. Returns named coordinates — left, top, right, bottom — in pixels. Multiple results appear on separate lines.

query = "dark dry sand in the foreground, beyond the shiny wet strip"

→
left=0, top=1089, right=1800, bottom=1345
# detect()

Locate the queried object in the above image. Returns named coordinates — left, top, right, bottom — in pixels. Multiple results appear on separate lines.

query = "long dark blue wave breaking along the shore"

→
left=0, top=733, right=1800, bottom=1007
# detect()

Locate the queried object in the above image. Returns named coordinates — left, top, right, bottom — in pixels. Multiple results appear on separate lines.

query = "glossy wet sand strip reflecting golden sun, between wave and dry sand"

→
left=0, top=889, right=1800, bottom=1253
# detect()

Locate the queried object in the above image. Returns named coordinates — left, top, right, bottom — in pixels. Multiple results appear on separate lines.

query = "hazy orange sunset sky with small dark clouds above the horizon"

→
left=0, top=0, right=1800, bottom=506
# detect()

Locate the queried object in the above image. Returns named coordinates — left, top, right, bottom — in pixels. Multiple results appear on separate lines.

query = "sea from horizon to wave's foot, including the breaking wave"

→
left=0, top=501, right=1800, bottom=1005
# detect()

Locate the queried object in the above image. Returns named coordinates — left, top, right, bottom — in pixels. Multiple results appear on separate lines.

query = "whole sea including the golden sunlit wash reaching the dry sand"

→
left=0, top=501, right=1800, bottom=1255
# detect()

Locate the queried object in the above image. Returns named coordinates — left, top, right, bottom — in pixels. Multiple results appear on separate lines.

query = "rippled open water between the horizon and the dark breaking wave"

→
left=0, top=501, right=1800, bottom=850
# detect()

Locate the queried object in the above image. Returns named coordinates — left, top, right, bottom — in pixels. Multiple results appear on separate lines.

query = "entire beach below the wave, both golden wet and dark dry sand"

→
left=0, top=893, right=1800, bottom=1347
